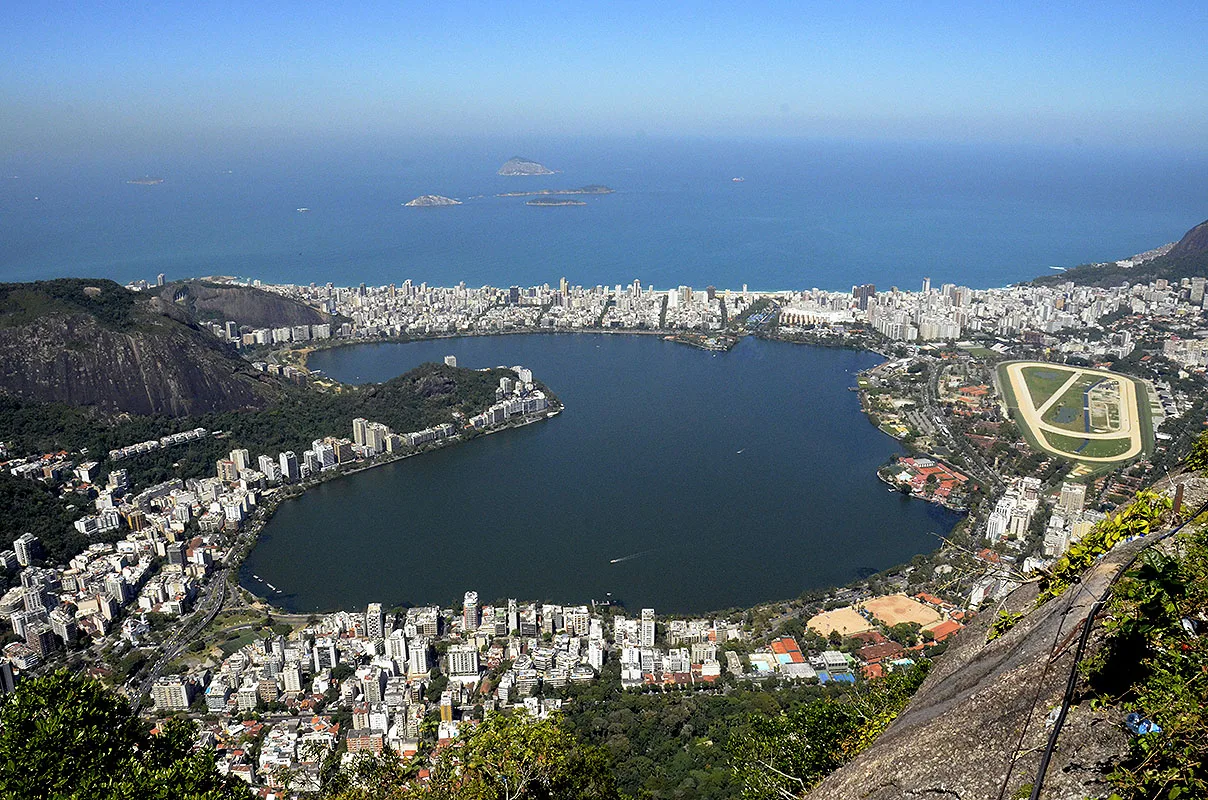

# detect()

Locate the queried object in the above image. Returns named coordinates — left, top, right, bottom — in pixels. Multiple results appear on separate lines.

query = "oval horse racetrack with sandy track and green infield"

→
left=998, top=361, right=1154, bottom=468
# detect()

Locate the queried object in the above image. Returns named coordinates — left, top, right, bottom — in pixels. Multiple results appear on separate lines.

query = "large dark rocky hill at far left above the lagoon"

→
left=0, top=280, right=280, bottom=416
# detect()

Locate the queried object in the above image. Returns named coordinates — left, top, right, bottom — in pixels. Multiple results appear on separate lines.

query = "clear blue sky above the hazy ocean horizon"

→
left=0, top=0, right=1208, bottom=152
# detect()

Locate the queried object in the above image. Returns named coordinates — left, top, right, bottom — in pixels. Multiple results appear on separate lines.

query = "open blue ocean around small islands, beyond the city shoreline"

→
left=0, top=137, right=1208, bottom=290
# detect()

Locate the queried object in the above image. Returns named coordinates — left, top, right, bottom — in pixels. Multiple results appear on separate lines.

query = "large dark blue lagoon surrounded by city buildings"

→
left=243, top=335, right=958, bottom=611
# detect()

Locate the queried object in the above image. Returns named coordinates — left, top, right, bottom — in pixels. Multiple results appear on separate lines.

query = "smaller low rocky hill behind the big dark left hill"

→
left=158, top=280, right=331, bottom=327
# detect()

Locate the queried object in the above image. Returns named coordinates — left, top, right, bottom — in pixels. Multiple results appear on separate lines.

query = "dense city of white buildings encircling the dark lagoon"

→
left=0, top=259, right=1208, bottom=796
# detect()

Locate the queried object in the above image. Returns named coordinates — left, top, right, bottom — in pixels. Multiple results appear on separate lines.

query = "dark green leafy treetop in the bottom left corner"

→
left=0, top=669, right=251, bottom=800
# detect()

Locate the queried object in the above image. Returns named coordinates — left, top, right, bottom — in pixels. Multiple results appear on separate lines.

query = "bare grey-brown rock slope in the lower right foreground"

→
left=808, top=541, right=1142, bottom=800
